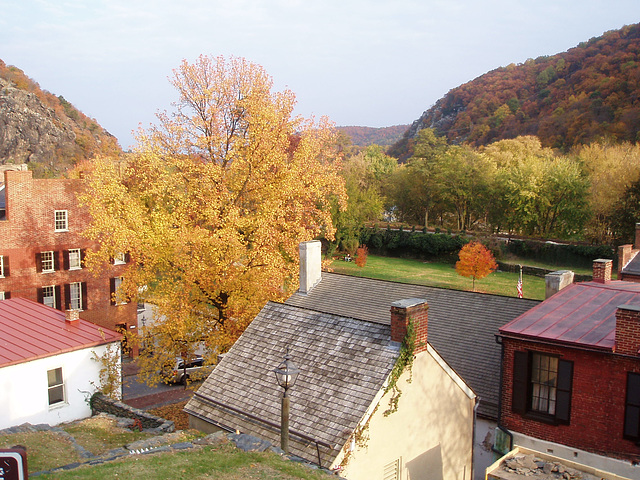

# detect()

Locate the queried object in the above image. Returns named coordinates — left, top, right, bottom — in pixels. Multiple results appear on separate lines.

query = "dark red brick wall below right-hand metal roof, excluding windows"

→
left=501, top=338, right=640, bottom=460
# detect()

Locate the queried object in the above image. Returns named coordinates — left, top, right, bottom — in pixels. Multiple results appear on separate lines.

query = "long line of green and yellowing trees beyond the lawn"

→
left=334, top=129, right=640, bottom=250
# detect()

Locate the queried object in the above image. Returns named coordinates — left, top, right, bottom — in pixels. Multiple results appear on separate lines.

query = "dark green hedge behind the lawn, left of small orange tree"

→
left=360, top=228, right=468, bottom=258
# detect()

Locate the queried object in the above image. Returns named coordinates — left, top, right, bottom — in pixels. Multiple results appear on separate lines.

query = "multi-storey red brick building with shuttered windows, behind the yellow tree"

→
left=0, top=170, right=137, bottom=350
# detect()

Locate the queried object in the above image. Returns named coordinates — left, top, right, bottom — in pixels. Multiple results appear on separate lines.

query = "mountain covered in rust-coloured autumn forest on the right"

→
left=389, top=24, right=640, bottom=159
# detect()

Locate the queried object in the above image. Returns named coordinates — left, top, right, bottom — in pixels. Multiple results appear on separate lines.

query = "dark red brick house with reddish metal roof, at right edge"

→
left=498, top=260, right=640, bottom=473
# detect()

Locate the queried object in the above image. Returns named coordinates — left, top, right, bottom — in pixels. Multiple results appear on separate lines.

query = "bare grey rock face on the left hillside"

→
left=0, top=78, right=76, bottom=173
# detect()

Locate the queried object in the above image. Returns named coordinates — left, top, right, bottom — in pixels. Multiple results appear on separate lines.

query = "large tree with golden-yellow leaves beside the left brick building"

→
left=83, top=56, right=345, bottom=383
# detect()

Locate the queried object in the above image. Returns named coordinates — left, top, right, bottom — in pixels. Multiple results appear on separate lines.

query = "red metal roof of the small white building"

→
left=0, top=298, right=122, bottom=367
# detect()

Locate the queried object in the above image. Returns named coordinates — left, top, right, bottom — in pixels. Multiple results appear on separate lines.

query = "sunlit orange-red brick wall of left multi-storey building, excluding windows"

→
left=0, top=171, right=137, bottom=340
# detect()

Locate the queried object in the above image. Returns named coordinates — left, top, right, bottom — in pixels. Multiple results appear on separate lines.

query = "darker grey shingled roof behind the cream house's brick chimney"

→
left=286, top=272, right=540, bottom=420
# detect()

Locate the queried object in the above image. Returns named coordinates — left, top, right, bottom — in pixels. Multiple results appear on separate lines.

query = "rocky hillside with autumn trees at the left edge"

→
left=0, top=60, right=120, bottom=177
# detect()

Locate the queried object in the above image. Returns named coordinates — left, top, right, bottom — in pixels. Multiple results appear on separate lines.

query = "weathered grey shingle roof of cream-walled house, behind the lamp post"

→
left=185, top=302, right=399, bottom=466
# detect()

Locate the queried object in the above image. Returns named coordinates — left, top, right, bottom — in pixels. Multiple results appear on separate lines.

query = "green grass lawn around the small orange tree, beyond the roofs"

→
left=331, top=255, right=545, bottom=300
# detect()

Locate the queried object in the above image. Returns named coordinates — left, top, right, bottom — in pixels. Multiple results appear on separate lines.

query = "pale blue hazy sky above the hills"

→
left=0, top=0, right=640, bottom=149
